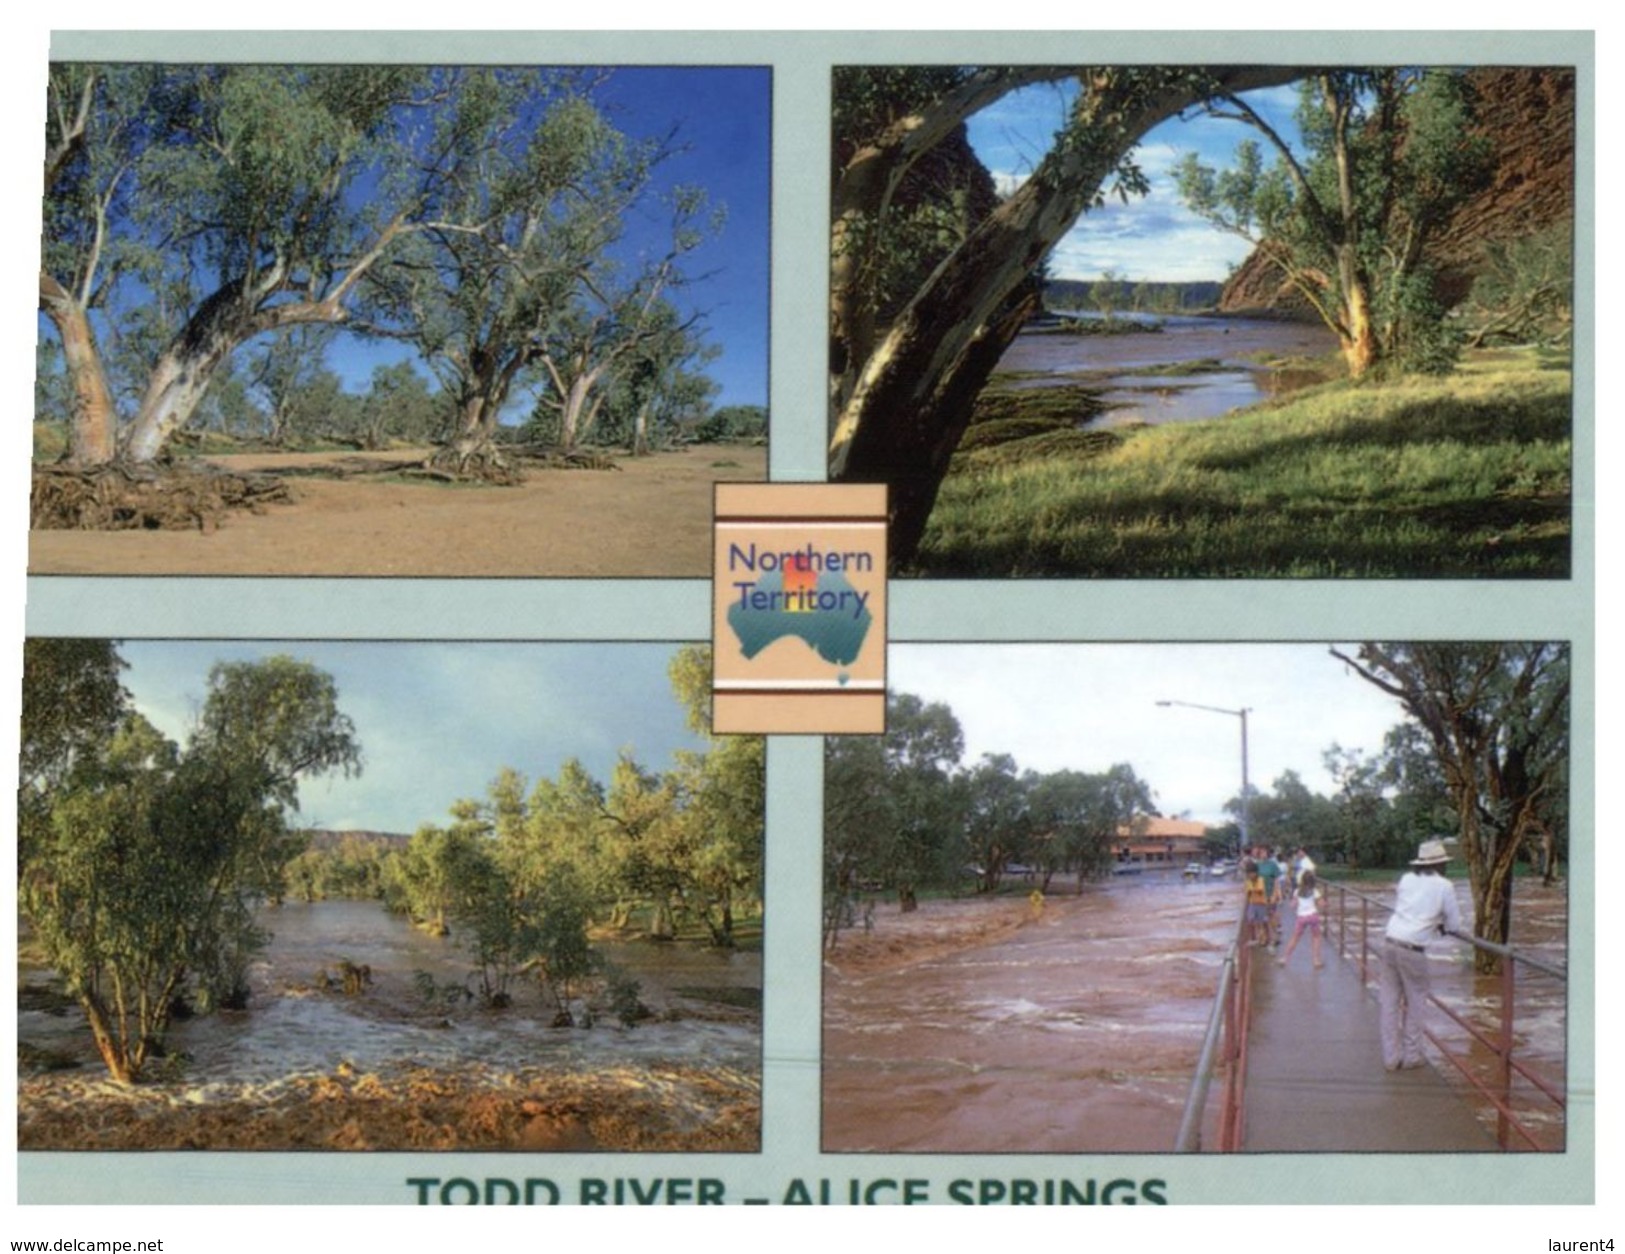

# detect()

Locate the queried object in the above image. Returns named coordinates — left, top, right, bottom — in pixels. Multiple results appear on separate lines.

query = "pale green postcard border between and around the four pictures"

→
left=22, top=31, right=1596, bottom=1202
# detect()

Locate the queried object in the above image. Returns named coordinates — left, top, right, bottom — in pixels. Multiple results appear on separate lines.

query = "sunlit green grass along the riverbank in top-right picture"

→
left=907, top=352, right=1571, bottom=578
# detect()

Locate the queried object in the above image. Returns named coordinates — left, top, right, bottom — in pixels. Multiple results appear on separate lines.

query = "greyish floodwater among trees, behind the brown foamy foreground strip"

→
left=18, top=902, right=762, bottom=1101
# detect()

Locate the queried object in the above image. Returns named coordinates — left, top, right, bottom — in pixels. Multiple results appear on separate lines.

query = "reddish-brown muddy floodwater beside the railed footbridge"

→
left=822, top=874, right=1567, bottom=1153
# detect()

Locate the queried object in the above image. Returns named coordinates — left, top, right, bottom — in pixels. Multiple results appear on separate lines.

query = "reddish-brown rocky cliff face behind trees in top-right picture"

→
left=1219, top=67, right=1575, bottom=317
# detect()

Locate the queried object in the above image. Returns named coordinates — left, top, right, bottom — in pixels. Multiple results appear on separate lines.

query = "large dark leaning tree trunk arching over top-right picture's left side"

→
left=829, top=65, right=1303, bottom=564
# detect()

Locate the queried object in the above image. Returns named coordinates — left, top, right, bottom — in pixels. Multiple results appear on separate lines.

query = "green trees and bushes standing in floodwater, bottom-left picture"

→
left=18, top=638, right=765, bottom=1083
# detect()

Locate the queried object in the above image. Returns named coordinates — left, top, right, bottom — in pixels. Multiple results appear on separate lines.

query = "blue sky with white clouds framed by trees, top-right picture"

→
left=969, top=84, right=1298, bottom=283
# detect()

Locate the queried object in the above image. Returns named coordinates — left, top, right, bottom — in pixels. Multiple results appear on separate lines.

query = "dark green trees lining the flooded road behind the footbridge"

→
left=824, top=642, right=1570, bottom=968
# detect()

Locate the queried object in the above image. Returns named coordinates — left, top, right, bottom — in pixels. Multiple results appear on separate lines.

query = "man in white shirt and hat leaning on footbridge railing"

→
left=1376, top=840, right=1461, bottom=1070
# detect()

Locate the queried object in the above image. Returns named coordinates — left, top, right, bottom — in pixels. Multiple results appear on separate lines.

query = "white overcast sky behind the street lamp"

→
left=887, top=643, right=1404, bottom=824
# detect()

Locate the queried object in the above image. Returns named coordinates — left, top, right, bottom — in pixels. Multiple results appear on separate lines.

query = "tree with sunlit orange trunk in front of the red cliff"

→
left=1178, top=68, right=1492, bottom=378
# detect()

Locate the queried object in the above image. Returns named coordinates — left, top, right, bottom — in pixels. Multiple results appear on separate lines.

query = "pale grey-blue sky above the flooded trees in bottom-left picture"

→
left=119, top=640, right=705, bottom=832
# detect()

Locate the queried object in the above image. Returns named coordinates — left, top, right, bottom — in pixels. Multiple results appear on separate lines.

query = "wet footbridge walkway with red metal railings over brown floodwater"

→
left=1177, top=884, right=1563, bottom=1153
